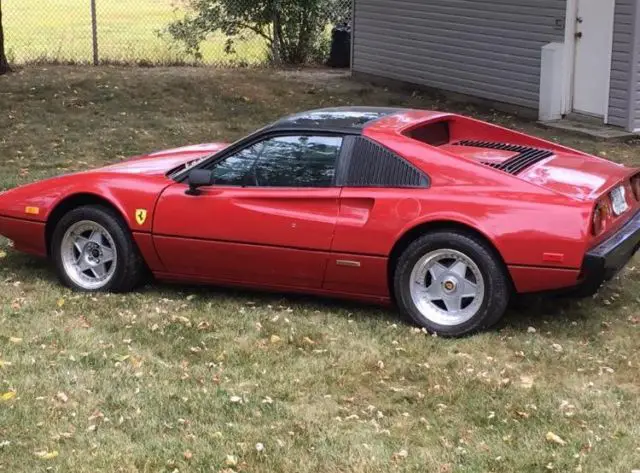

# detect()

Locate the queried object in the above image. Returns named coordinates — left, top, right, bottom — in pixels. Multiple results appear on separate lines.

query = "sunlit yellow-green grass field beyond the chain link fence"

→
left=2, top=0, right=266, bottom=64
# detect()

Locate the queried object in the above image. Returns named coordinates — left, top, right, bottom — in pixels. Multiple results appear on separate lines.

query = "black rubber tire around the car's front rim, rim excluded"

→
left=51, top=205, right=145, bottom=292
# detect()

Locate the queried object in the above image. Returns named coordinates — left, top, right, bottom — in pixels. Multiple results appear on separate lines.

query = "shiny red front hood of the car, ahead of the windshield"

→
left=95, top=143, right=228, bottom=176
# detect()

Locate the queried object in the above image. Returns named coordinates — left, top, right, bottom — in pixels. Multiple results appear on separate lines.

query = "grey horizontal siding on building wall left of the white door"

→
left=353, top=0, right=566, bottom=109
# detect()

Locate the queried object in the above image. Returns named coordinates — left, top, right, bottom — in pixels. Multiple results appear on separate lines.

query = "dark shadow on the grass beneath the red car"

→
left=0, top=250, right=616, bottom=338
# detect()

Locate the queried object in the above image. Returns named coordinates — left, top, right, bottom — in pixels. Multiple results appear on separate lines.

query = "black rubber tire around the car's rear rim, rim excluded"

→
left=393, top=230, right=511, bottom=337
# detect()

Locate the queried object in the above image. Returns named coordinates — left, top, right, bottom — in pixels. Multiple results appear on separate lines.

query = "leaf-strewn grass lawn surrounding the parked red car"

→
left=0, top=67, right=640, bottom=473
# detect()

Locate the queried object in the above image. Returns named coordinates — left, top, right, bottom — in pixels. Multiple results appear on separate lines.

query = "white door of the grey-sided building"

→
left=573, top=0, right=615, bottom=117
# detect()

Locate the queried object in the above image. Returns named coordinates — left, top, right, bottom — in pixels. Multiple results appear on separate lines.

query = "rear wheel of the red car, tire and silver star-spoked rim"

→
left=394, top=231, right=510, bottom=336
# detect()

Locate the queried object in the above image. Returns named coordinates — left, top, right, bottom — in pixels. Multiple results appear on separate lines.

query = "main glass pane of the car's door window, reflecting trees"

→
left=255, top=136, right=342, bottom=187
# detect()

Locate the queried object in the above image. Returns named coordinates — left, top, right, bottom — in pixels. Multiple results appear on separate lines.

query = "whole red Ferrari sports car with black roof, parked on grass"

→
left=0, top=107, right=640, bottom=336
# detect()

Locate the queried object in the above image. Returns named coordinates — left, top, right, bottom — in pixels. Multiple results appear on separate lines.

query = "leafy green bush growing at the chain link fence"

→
left=168, top=0, right=344, bottom=64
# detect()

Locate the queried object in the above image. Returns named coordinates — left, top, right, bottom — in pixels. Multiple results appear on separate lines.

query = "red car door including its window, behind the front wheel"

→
left=153, top=134, right=343, bottom=288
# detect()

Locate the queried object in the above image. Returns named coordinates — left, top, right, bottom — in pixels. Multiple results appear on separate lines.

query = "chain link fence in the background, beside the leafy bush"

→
left=2, top=0, right=352, bottom=66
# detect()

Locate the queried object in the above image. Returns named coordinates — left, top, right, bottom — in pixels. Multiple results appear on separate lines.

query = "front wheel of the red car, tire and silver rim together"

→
left=51, top=206, right=143, bottom=292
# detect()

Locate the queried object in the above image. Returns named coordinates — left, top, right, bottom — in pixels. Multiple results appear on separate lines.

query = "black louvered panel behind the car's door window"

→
left=344, top=136, right=429, bottom=187
